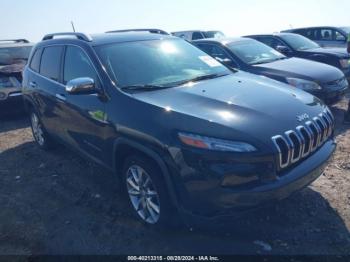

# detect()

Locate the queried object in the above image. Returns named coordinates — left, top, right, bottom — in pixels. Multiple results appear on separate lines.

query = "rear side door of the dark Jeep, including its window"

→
left=28, top=46, right=63, bottom=135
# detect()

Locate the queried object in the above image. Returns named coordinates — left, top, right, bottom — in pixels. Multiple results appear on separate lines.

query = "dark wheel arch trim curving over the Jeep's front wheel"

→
left=113, top=137, right=182, bottom=213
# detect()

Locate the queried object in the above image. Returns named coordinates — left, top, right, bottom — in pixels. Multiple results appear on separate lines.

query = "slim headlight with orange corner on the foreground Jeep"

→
left=179, top=132, right=257, bottom=152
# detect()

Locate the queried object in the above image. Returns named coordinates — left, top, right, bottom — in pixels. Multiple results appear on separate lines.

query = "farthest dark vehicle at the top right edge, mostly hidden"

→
left=282, top=26, right=350, bottom=49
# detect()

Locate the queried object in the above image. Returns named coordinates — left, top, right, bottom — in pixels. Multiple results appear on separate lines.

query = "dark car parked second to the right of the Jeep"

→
left=246, top=33, right=350, bottom=80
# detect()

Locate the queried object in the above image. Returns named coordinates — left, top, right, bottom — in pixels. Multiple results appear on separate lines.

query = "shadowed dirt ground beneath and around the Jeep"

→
left=0, top=98, right=350, bottom=255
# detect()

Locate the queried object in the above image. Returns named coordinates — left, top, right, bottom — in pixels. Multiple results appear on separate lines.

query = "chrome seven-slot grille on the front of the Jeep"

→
left=271, top=108, right=334, bottom=169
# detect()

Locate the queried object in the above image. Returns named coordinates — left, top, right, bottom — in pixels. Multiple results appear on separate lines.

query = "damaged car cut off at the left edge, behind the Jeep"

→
left=0, top=39, right=33, bottom=115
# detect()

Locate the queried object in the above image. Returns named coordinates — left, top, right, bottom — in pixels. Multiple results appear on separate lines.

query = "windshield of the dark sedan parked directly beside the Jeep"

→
left=227, top=40, right=286, bottom=65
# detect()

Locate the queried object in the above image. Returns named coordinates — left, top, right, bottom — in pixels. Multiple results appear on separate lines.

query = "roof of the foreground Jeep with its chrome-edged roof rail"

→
left=39, top=32, right=177, bottom=46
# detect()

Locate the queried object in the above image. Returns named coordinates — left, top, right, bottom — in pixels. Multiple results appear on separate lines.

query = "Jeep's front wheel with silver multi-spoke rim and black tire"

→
left=122, top=155, right=173, bottom=226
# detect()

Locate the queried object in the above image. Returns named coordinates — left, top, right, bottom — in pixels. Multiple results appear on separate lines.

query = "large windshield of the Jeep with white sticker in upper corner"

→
left=95, top=39, right=230, bottom=88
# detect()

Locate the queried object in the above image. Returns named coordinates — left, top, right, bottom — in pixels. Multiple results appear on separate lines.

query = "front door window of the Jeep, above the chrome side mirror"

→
left=63, top=46, right=98, bottom=84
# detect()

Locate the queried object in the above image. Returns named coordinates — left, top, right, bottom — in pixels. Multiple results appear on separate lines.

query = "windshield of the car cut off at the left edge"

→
left=0, top=46, right=32, bottom=65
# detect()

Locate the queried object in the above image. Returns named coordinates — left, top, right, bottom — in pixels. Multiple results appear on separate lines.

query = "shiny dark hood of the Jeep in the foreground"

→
left=133, top=72, right=324, bottom=144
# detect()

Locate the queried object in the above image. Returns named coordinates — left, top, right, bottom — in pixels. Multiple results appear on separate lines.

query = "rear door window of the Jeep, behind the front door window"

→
left=40, top=46, right=63, bottom=81
